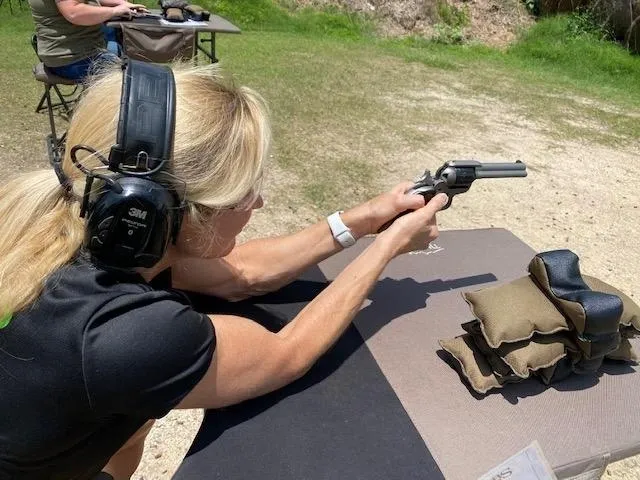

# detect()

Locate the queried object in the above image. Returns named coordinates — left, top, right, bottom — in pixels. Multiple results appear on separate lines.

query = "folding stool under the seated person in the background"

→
left=31, top=34, right=81, bottom=163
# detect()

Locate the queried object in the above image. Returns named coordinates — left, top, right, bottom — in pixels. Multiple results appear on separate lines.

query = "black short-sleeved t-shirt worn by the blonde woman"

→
left=0, top=259, right=215, bottom=480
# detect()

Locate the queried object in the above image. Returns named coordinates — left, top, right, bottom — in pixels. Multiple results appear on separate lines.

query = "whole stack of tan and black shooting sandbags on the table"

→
left=440, top=250, right=640, bottom=393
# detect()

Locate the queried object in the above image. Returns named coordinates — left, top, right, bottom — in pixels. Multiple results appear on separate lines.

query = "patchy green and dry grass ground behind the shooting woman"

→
left=0, top=0, right=640, bottom=211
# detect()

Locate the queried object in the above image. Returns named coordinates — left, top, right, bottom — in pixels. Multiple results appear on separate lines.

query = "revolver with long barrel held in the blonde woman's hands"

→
left=378, top=160, right=527, bottom=233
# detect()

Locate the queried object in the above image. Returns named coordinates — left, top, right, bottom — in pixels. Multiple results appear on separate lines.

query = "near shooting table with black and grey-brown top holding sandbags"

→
left=174, top=229, right=640, bottom=480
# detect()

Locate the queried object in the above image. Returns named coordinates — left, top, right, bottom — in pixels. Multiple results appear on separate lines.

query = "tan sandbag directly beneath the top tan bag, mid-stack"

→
left=496, top=333, right=578, bottom=378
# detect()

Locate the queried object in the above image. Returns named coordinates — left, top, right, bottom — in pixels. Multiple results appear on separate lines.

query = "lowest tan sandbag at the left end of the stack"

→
left=439, top=333, right=521, bottom=394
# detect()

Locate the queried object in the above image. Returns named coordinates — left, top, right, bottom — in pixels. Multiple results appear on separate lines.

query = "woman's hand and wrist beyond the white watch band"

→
left=341, top=182, right=425, bottom=238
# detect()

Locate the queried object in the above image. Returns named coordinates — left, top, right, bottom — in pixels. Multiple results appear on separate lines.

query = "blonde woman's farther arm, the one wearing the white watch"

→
left=173, top=183, right=424, bottom=300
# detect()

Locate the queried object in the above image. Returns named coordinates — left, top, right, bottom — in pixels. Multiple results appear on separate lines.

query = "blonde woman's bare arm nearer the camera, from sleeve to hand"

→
left=178, top=193, right=446, bottom=408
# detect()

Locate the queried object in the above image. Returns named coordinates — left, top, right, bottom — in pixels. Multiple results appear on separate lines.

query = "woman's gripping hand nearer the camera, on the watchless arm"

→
left=378, top=193, right=448, bottom=257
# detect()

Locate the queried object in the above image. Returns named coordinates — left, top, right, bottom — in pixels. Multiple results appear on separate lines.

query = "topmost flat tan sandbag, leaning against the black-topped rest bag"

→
left=462, top=276, right=570, bottom=348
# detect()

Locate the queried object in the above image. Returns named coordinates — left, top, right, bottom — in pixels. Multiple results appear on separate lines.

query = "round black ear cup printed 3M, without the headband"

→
left=85, top=176, right=182, bottom=268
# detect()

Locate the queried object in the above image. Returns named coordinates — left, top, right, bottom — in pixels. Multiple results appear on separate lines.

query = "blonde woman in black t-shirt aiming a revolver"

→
left=0, top=63, right=446, bottom=480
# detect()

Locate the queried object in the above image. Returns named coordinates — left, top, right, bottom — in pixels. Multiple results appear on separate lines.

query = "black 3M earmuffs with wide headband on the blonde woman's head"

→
left=77, top=60, right=183, bottom=269
